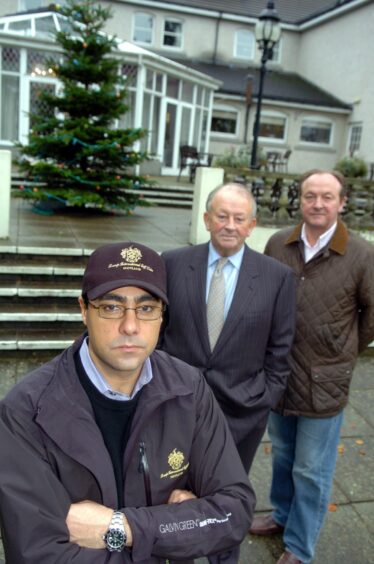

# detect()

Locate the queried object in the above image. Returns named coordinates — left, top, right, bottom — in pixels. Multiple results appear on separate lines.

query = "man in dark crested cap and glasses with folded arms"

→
left=0, top=243, right=254, bottom=564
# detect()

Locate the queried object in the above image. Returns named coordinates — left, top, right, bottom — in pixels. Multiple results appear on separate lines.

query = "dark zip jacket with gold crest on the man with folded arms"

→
left=0, top=339, right=254, bottom=564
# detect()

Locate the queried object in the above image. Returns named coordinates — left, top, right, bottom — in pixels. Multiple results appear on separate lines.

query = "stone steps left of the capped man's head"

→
left=0, top=247, right=89, bottom=352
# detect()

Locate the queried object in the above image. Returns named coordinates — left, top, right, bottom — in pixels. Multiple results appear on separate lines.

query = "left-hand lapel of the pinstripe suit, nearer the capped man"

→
left=186, top=243, right=210, bottom=354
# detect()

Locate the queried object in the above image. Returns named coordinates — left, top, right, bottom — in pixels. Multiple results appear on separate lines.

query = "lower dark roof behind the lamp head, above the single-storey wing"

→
left=175, top=61, right=351, bottom=110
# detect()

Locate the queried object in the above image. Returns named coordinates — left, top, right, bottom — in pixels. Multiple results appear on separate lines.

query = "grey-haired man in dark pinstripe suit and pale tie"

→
left=159, top=184, right=295, bottom=472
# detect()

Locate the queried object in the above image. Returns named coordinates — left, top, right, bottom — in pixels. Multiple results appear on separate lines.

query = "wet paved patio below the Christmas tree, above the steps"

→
left=0, top=198, right=191, bottom=252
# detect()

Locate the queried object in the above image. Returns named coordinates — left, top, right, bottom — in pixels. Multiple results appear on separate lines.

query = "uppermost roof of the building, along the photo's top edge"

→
left=157, top=0, right=355, bottom=24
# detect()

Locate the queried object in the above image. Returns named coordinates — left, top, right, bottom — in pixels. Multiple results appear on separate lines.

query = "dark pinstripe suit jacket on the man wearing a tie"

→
left=160, top=244, right=295, bottom=450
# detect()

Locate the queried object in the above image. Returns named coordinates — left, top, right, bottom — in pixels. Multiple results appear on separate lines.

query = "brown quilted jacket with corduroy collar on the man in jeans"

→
left=265, top=221, right=374, bottom=417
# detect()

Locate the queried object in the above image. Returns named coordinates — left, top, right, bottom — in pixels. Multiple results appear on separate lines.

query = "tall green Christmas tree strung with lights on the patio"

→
left=17, top=0, right=146, bottom=211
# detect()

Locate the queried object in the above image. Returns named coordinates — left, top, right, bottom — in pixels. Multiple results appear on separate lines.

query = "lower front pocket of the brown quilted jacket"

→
left=312, top=362, right=353, bottom=413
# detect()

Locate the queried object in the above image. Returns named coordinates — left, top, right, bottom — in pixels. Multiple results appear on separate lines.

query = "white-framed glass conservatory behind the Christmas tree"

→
left=0, top=10, right=219, bottom=175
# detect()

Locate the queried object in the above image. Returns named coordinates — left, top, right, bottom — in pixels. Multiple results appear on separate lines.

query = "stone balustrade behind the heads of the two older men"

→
left=225, top=169, right=374, bottom=230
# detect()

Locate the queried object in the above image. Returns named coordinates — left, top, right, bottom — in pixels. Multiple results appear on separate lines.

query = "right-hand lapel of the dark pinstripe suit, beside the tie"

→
left=214, top=246, right=259, bottom=354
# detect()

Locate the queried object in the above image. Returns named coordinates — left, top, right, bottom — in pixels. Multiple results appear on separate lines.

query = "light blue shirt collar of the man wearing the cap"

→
left=79, top=337, right=153, bottom=401
